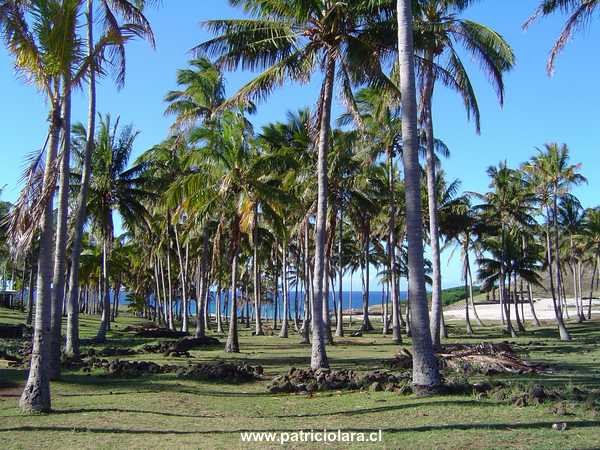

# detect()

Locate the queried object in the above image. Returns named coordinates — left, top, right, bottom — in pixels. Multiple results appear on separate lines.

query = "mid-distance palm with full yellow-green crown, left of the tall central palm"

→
left=170, top=111, right=282, bottom=352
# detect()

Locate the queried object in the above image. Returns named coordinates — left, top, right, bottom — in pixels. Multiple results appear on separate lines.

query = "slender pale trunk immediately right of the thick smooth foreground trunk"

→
left=422, top=57, right=445, bottom=348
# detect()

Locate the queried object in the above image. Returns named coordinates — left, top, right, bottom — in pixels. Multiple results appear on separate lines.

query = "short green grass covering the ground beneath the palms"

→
left=0, top=308, right=600, bottom=449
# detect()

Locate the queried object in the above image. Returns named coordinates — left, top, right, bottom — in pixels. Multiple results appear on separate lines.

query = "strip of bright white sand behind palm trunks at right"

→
left=444, top=298, right=600, bottom=321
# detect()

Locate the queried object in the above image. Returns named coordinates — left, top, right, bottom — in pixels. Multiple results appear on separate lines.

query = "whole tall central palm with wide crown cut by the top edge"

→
left=197, top=0, right=391, bottom=368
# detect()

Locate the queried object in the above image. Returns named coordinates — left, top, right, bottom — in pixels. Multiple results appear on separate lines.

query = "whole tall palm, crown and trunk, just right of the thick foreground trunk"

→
left=415, top=0, right=515, bottom=347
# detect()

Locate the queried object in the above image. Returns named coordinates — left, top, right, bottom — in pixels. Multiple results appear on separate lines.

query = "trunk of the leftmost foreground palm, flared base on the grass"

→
left=19, top=98, right=60, bottom=412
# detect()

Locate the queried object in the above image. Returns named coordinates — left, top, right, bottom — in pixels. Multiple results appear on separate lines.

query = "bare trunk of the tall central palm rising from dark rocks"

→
left=310, top=53, right=335, bottom=369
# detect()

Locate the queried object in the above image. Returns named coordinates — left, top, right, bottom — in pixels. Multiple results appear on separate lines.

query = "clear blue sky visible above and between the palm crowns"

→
left=0, top=0, right=600, bottom=287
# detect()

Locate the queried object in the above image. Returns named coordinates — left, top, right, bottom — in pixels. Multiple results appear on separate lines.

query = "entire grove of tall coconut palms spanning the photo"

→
left=0, top=0, right=598, bottom=411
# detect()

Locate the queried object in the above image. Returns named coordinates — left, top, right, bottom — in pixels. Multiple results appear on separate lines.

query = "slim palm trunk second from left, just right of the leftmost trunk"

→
left=48, top=76, right=71, bottom=380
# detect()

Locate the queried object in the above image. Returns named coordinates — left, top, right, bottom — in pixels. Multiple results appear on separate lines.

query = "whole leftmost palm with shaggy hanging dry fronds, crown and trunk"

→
left=0, top=0, right=85, bottom=412
